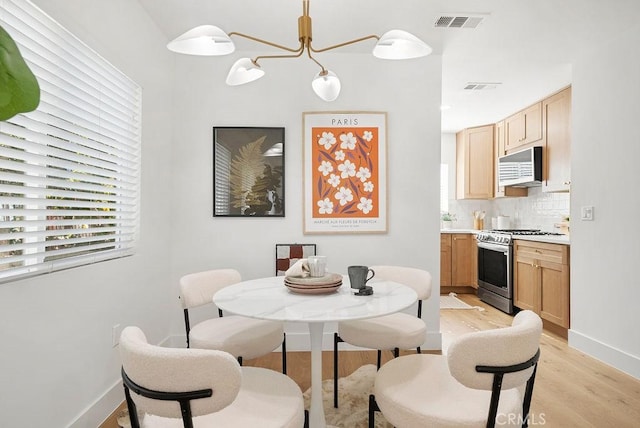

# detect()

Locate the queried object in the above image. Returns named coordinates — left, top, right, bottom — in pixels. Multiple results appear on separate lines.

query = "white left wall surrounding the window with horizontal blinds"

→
left=0, top=0, right=175, bottom=428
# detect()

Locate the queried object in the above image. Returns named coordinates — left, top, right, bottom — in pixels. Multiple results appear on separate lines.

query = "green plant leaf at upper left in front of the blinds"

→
left=0, top=26, right=40, bottom=121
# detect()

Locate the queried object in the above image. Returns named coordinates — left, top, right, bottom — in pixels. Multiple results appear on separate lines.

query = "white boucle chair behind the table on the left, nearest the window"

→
left=180, top=269, right=287, bottom=374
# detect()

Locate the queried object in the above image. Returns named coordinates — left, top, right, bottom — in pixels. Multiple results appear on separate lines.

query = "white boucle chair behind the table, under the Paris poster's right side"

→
left=333, top=266, right=431, bottom=407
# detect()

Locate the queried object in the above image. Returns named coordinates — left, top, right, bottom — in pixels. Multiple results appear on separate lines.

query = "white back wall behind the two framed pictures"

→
left=172, top=53, right=441, bottom=349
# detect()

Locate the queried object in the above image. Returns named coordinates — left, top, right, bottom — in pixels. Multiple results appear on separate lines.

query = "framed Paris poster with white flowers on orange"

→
left=302, top=112, right=387, bottom=234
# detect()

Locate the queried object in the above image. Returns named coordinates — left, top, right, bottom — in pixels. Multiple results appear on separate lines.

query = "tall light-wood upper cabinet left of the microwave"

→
left=456, top=125, right=494, bottom=199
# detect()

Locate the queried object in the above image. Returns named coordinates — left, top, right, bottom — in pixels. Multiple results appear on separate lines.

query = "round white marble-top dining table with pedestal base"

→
left=213, top=275, right=418, bottom=428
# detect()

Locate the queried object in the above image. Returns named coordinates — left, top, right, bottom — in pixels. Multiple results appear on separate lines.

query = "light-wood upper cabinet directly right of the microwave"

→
left=542, top=87, right=571, bottom=192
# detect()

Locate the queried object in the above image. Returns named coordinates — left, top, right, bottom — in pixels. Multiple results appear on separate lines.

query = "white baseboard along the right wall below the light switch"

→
left=569, top=330, right=640, bottom=379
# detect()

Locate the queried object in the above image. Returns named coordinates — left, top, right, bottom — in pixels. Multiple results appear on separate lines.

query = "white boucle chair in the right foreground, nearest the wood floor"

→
left=369, top=311, right=542, bottom=428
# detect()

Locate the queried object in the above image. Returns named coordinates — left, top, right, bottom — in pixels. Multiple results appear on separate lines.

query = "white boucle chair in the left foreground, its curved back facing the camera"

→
left=120, top=326, right=308, bottom=428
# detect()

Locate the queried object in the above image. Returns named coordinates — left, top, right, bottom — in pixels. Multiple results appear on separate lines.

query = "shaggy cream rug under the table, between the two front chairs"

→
left=304, top=364, right=391, bottom=428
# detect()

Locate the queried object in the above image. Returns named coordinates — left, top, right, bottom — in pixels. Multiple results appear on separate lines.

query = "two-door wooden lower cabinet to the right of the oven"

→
left=513, top=240, right=569, bottom=329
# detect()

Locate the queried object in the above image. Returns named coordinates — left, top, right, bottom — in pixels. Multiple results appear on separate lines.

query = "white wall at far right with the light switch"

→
left=569, top=26, right=640, bottom=378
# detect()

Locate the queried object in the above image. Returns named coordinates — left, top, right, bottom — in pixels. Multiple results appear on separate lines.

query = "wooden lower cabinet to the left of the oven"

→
left=440, top=233, right=478, bottom=287
